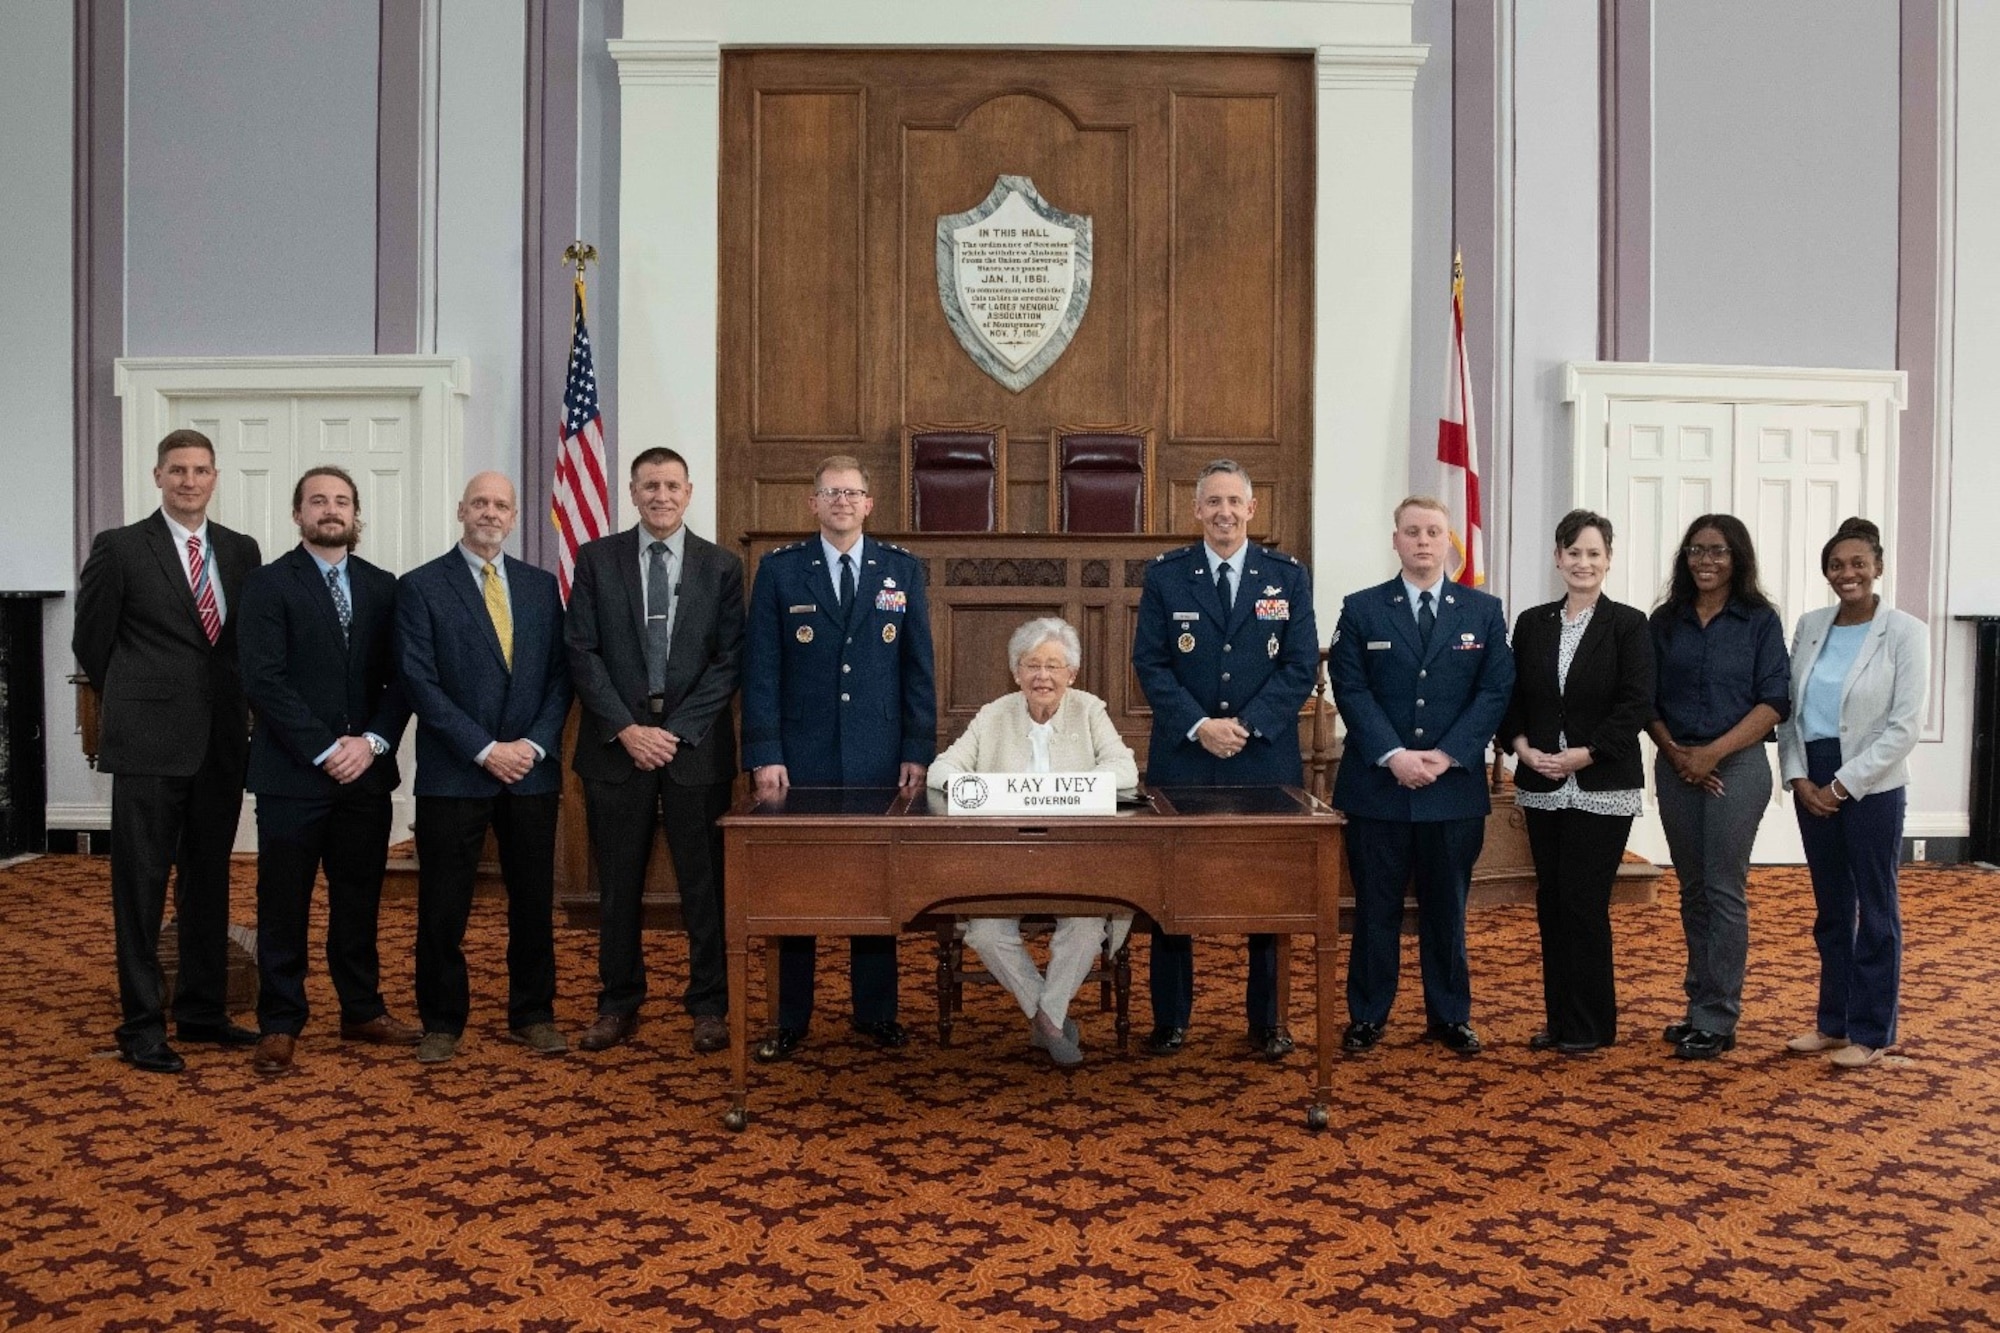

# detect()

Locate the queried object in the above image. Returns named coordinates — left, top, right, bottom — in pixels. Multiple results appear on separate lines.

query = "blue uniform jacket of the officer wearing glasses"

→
left=744, top=536, right=938, bottom=787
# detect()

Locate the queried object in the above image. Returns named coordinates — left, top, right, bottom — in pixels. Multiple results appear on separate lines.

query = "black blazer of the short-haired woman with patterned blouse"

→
left=1494, top=596, right=1654, bottom=791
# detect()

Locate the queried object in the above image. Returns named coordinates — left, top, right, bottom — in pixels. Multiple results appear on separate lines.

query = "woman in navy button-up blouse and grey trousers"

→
left=1648, top=514, right=1792, bottom=1061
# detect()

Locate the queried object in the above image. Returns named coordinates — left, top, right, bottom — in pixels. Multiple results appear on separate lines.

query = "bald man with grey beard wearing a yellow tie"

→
left=396, top=472, right=570, bottom=1065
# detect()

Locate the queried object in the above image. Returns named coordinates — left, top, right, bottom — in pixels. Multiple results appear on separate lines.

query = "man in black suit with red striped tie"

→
left=70, top=430, right=262, bottom=1073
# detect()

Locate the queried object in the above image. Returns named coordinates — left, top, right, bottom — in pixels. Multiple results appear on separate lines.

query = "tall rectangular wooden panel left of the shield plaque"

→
left=750, top=88, right=866, bottom=440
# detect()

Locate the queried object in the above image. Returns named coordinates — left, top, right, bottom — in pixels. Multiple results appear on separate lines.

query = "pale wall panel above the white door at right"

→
left=1652, top=0, right=1898, bottom=368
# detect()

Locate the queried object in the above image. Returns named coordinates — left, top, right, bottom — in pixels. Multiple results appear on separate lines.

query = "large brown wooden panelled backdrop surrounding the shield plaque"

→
left=714, top=50, right=1314, bottom=550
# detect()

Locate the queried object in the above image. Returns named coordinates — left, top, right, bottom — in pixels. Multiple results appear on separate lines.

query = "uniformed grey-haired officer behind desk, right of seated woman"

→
left=1132, top=458, right=1320, bottom=1061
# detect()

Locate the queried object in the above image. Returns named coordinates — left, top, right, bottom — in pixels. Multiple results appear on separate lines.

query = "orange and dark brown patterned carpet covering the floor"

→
left=0, top=857, right=2000, bottom=1331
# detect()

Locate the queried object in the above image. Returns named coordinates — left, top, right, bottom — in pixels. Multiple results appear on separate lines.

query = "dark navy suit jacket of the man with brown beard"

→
left=236, top=546, right=410, bottom=797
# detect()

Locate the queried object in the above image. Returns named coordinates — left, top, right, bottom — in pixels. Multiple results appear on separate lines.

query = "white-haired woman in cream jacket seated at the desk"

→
left=930, top=616, right=1138, bottom=1065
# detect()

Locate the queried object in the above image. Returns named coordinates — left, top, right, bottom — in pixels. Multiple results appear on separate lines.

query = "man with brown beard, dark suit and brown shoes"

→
left=236, top=466, right=420, bottom=1075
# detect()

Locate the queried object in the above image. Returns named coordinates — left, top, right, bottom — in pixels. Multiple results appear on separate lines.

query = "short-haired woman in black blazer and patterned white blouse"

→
left=1496, top=508, right=1654, bottom=1055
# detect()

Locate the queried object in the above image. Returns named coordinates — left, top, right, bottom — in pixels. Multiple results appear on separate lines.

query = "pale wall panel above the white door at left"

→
left=126, top=0, right=378, bottom=356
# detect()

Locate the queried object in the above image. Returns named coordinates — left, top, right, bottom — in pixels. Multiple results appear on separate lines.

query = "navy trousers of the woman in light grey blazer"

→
left=1798, top=741, right=1908, bottom=1047
